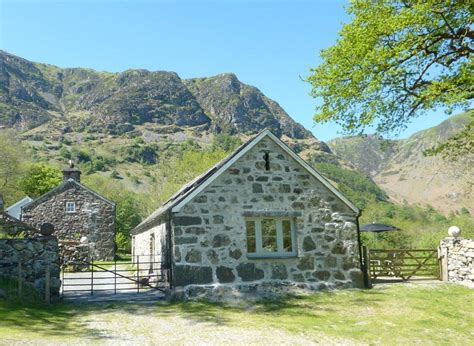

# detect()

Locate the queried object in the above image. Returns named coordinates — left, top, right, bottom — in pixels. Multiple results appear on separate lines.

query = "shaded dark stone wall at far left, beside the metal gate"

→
left=0, top=236, right=61, bottom=298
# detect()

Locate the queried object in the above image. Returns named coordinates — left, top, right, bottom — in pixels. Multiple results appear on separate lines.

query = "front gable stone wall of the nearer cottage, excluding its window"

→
left=172, top=139, right=363, bottom=292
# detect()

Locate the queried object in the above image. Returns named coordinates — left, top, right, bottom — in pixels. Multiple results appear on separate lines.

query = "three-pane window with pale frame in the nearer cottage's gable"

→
left=245, top=217, right=296, bottom=257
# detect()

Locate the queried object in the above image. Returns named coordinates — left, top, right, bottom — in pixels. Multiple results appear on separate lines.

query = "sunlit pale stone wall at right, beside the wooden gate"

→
left=439, top=237, right=474, bottom=284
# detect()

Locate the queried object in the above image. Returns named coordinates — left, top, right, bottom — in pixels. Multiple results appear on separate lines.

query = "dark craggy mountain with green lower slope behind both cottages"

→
left=0, top=51, right=348, bottom=200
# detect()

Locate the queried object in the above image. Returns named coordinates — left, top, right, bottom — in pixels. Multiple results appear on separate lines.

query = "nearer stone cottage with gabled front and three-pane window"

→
left=132, top=130, right=363, bottom=296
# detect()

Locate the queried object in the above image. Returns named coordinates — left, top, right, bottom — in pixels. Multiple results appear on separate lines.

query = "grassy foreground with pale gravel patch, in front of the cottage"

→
left=0, top=284, right=474, bottom=345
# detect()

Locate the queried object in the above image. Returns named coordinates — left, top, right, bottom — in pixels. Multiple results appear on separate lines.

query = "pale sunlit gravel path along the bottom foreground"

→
left=78, top=313, right=348, bottom=345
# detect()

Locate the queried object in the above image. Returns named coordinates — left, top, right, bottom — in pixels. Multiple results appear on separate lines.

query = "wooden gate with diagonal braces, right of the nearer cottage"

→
left=366, top=249, right=441, bottom=281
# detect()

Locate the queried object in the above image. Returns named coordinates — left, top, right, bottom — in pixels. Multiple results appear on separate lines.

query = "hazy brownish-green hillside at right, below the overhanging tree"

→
left=328, top=110, right=474, bottom=213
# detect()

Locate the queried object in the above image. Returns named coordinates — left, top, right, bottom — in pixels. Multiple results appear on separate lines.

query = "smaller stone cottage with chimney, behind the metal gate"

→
left=22, top=162, right=115, bottom=260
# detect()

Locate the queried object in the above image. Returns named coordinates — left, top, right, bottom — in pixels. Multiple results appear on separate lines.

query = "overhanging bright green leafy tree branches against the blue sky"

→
left=307, top=0, right=474, bottom=139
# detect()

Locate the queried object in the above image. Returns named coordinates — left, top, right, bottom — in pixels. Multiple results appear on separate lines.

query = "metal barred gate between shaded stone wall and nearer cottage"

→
left=61, top=256, right=169, bottom=297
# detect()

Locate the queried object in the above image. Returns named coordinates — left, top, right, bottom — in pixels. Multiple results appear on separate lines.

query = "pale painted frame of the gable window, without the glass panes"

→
left=244, top=216, right=298, bottom=258
